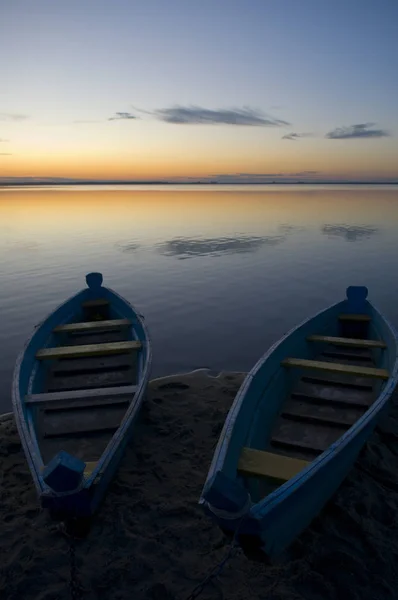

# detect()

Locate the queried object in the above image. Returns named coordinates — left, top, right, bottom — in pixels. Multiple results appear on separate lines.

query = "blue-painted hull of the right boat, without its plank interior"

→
left=199, top=288, right=398, bottom=558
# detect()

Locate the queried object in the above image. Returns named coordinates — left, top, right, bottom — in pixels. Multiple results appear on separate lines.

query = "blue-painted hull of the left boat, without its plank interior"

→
left=12, top=273, right=152, bottom=518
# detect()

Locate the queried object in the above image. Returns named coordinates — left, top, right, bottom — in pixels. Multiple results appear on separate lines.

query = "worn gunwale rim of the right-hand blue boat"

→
left=199, top=300, right=398, bottom=519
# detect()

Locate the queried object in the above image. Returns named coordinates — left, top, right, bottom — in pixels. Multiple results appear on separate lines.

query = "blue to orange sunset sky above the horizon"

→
left=0, top=0, right=398, bottom=181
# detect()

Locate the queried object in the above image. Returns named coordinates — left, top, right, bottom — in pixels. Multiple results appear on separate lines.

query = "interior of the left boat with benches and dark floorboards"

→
left=25, top=298, right=141, bottom=477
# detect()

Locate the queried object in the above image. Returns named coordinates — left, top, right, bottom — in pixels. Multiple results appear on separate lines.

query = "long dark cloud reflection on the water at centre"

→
left=157, top=235, right=286, bottom=260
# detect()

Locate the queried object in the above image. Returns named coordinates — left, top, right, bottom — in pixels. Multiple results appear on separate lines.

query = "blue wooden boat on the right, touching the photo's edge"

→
left=200, top=287, right=398, bottom=559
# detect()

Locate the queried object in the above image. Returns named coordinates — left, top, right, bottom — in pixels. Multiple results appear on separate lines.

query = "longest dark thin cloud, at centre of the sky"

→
left=152, top=106, right=289, bottom=127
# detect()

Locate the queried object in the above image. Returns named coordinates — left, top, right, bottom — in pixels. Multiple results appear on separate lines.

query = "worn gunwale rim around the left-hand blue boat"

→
left=11, top=286, right=152, bottom=497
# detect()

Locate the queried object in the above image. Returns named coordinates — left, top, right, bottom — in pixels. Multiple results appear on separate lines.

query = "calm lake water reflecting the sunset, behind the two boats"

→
left=0, top=185, right=398, bottom=412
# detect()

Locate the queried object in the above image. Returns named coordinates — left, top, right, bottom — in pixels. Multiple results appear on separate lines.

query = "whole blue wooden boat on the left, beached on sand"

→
left=12, top=273, right=151, bottom=520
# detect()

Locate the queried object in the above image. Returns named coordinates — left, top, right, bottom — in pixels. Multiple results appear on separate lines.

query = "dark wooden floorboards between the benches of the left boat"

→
left=36, top=318, right=137, bottom=463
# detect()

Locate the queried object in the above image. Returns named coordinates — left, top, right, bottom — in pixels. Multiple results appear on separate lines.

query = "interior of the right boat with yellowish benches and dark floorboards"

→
left=237, top=314, right=389, bottom=502
